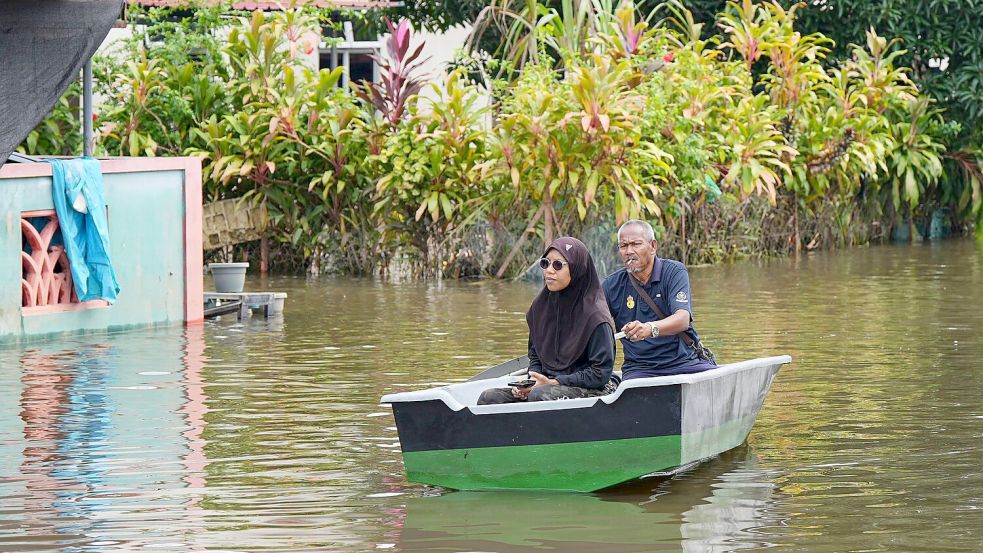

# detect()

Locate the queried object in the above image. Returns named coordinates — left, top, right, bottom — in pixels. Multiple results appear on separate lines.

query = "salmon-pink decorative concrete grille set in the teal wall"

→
left=20, top=210, right=79, bottom=307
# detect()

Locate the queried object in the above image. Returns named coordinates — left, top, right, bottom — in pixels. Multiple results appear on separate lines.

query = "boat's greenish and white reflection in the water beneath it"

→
left=398, top=447, right=775, bottom=553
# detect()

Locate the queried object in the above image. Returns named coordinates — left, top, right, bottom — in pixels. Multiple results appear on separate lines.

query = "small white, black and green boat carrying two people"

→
left=382, top=355, right=792, bottom=492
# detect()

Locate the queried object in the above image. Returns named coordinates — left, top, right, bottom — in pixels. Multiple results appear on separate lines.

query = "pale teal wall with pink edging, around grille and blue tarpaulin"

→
left=0, top=170, right=186, bottom=343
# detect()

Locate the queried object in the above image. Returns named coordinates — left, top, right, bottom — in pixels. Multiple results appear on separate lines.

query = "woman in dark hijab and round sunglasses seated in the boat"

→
left=478, top=237, right=620, bottom=405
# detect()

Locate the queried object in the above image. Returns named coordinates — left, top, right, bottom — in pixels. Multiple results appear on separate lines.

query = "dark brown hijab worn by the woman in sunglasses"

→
left=526, top=236, right=613, bottom=370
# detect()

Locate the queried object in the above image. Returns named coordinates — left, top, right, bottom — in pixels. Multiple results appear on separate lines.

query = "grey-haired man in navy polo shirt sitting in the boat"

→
left=603, top=219, right=716, bottom=380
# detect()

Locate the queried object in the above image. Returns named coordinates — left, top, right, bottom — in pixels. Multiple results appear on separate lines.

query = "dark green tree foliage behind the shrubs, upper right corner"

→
left=668, top=0, right=983, bottom=239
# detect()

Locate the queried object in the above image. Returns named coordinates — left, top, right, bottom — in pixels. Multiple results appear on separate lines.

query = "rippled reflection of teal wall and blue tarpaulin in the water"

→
left=0, top=328, right=206, bottom=551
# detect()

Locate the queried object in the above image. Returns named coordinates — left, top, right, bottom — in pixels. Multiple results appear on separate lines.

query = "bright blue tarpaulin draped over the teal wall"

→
left=48, top=158, right=119, bottom=303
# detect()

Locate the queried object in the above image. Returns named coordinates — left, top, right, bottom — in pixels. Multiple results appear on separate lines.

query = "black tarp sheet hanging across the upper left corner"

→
left=0, top=0, right=123, bottom=166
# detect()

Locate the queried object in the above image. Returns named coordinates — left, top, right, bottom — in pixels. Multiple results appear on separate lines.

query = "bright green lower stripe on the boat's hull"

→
left=403, top=436, right=681, bottom=492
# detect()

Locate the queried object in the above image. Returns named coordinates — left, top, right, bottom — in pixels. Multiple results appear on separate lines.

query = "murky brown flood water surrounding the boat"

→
left=0, top=241, right=983, bottom=552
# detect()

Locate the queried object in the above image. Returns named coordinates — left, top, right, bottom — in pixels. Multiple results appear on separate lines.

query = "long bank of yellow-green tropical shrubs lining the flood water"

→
left=19, top=0, right=983, bottom=276
